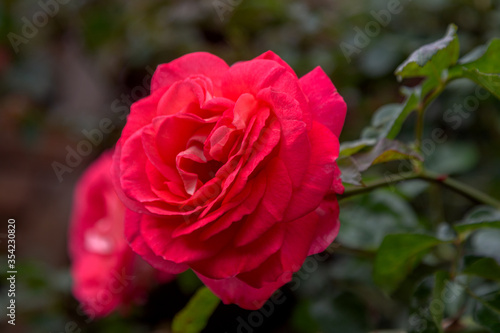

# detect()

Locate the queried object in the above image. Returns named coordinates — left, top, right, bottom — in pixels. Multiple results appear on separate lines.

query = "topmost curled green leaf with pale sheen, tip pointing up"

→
left=395, top=24, right=460, bottom=81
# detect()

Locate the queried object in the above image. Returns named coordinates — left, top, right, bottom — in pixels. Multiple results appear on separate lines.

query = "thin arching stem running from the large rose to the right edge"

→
left=339, top=171, right=500, bottom=209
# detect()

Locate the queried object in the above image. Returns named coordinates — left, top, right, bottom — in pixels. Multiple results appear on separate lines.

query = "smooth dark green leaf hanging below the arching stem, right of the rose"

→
left=373, top=234, right=442, bottom=292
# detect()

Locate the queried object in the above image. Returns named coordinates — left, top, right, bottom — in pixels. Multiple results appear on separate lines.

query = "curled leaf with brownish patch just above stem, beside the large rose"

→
left=352, top=139, right=423, bottom=171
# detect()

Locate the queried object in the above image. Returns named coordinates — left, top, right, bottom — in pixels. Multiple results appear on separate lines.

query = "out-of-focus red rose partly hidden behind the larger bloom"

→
left=69, top=152, right=173, bottom=318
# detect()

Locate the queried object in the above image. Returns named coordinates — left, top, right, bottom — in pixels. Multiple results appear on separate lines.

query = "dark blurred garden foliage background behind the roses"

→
left=0, top=0, right=500, bottom=333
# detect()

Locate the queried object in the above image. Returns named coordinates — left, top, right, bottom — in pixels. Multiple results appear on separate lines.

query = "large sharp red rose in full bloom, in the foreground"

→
left=113, top=52, right=346, bottom=309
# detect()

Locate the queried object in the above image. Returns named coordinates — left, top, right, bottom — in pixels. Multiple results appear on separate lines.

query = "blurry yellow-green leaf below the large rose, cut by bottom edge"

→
left=172, top=287, right=220, bottom=333
